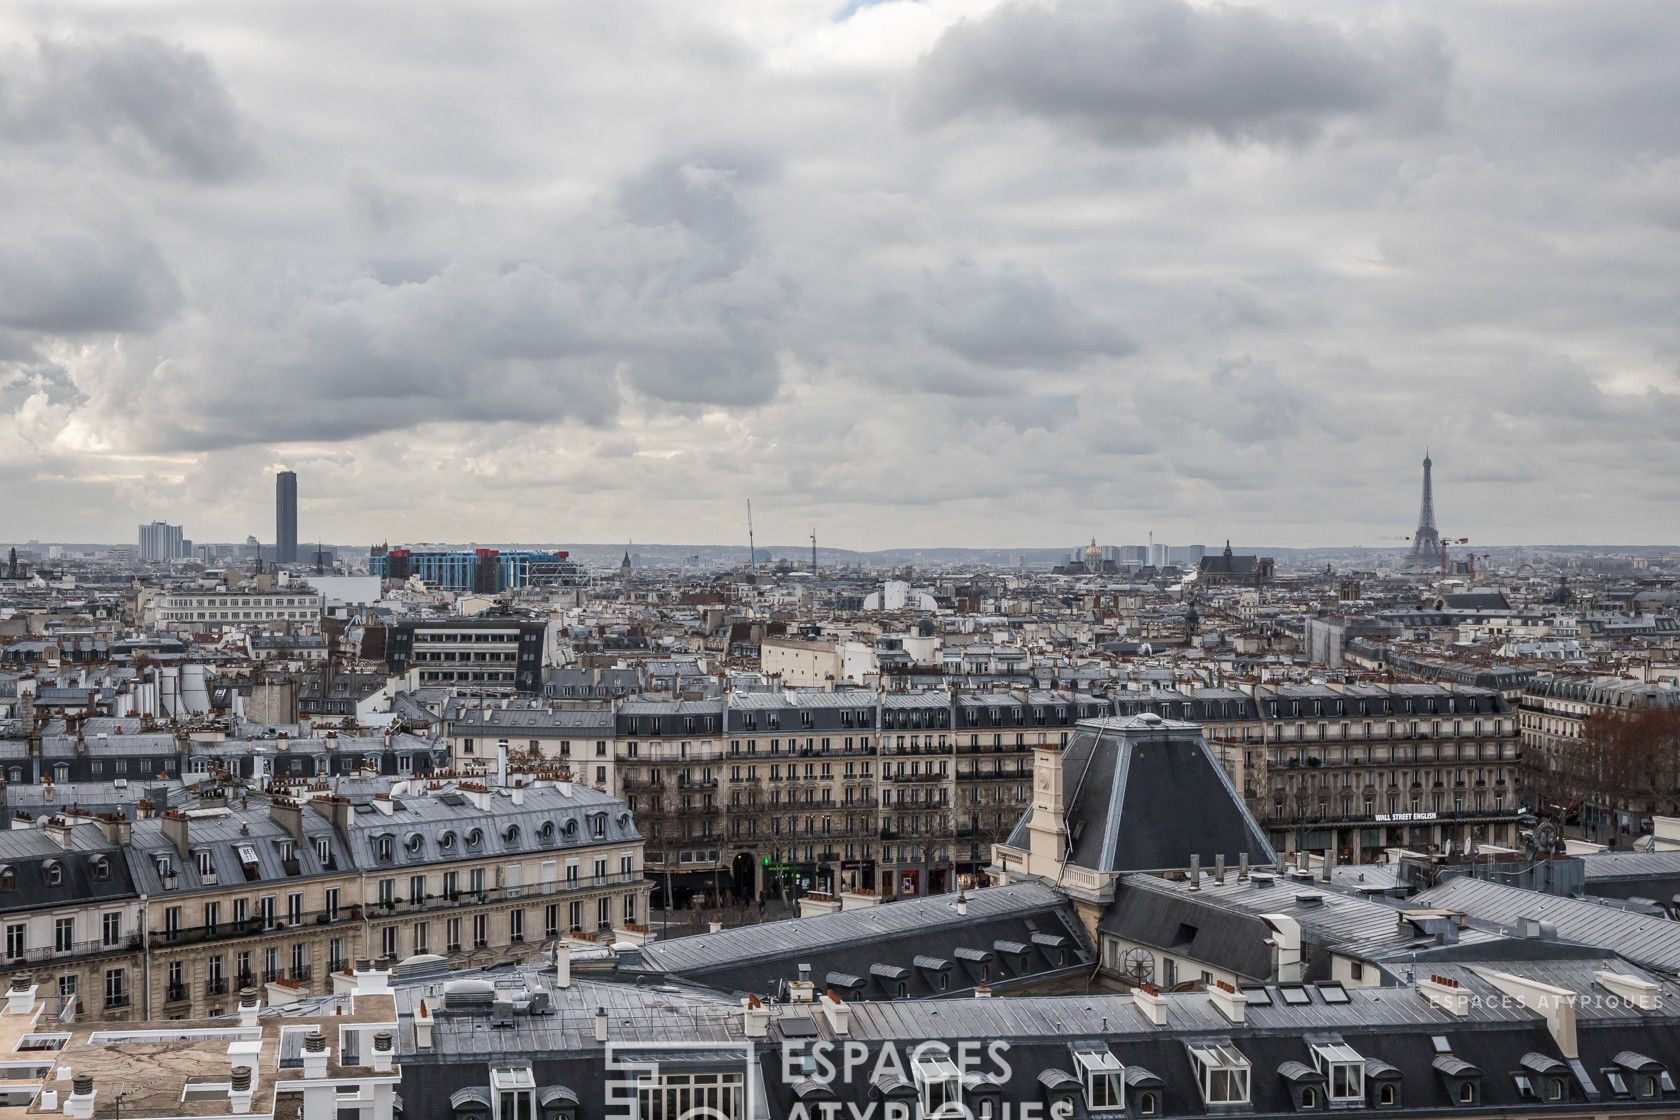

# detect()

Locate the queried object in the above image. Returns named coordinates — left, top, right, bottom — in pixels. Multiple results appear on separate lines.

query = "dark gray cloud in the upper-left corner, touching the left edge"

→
left=0, top=34, right=254, bottom=180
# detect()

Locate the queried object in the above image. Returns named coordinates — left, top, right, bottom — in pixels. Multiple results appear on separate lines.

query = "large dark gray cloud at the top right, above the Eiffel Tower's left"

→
left=912, top=0, right=1450, bottom=144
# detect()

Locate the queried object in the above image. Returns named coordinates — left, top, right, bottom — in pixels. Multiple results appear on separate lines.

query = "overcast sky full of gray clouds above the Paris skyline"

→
left=0, top=0, right=1680, bottom=547
